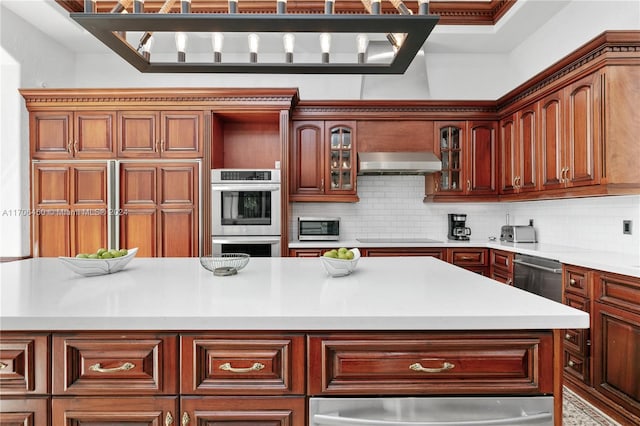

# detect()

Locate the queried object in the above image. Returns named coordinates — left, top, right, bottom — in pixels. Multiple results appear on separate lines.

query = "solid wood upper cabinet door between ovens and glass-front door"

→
left=291, top=121, right=324, bottom=201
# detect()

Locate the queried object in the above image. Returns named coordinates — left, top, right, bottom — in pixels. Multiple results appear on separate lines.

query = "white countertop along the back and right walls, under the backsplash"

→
left=289, top=237, right=640, bottom=278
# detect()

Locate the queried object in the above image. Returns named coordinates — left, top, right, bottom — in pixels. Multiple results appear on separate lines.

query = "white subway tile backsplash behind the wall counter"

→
left=290, top=176, right=640, bottom=256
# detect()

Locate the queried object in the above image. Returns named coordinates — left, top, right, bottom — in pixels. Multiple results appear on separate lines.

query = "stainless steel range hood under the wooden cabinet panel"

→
left=358, top=152, right=442, bottom=175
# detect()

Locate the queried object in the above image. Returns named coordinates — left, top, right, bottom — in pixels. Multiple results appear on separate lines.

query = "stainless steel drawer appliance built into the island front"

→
left=309, top=396, right=553, bottom=426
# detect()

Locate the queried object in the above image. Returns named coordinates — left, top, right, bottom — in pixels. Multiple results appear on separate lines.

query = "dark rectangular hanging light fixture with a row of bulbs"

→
left=70, top=0, right=439, bottom=74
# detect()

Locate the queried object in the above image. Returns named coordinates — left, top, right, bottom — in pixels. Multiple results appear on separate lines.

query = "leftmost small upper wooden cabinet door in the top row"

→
left=29, top=111, right=73, bottom=159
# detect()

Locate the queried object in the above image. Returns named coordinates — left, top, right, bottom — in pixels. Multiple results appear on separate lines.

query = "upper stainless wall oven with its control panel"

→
left=211, top=169, right=282, bottom=236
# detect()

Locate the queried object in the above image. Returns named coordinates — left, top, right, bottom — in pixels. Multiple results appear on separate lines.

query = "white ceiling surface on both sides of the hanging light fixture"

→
left=0, top=0, right=572, bottom=54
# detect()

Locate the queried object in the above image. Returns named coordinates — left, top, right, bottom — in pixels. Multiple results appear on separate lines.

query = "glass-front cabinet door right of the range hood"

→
left=437, top=123, right=464, bottom=192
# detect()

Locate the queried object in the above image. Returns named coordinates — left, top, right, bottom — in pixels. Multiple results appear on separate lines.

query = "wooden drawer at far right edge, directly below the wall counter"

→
left=596, top=273, right=640, bottom=313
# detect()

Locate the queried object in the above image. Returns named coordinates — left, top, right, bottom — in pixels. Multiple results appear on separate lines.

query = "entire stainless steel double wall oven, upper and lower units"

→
left=211, top=169, right=282, bottom=257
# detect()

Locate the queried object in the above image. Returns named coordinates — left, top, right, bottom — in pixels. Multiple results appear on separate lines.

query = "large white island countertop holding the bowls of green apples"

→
left=0, top=257, right=589, bottom=331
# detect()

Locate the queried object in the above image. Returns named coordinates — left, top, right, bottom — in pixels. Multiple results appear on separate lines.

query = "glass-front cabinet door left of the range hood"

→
left=329, top=126, right=354, bottom=191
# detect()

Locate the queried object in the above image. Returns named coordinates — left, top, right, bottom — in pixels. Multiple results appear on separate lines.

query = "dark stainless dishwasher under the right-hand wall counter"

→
left=513, top=254, right=562, bottom=303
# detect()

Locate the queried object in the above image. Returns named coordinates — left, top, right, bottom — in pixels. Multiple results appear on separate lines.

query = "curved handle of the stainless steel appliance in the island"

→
left=313, top=413, right=553, bottom=426
